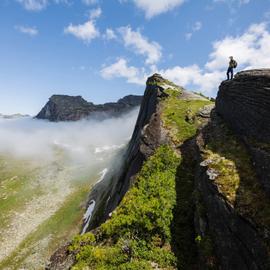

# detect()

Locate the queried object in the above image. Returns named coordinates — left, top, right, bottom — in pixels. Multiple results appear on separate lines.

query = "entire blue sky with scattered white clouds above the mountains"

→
left=0, top=0, right=270, bottom=115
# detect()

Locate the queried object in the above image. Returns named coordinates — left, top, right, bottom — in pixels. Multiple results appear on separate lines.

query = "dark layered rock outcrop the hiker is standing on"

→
left=216, top=69, right=270, bottom=194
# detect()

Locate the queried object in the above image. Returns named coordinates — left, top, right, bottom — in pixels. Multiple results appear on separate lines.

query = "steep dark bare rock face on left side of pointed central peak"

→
left=80, top=74, right=173, bottom=230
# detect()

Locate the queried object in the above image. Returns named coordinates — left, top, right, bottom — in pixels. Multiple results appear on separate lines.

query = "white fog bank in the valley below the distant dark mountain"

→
left=0, top=109, right=138, bottom=165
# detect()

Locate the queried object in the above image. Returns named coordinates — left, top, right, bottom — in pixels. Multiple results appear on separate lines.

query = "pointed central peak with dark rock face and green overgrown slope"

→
left=48, top=74, right=213, bottom=269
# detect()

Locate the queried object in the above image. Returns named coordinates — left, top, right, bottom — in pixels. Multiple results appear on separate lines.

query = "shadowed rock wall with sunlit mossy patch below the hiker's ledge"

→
left=194, top=111, right=270, bottom=270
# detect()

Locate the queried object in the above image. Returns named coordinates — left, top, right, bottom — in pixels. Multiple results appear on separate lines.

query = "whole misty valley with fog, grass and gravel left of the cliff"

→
left=0, top=109, right=138, bottom=269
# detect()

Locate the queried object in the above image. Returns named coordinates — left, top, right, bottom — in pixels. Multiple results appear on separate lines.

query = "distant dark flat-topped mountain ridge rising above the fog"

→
left=36, top=95, right=142, bottom=121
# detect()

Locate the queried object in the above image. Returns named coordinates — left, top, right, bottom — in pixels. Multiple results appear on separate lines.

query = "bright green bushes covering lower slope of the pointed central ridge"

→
left=69, top=146, right=180, bottom=270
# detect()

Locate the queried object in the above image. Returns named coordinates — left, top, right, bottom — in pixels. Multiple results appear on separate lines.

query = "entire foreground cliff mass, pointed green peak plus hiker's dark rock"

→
left=48, top=70, right=270, bottom=270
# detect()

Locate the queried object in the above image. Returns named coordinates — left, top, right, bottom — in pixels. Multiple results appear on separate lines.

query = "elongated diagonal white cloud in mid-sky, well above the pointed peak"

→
left=118, top=26, right=162, bottom=64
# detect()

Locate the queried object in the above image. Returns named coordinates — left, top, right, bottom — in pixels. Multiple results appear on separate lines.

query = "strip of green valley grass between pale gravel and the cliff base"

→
left=0, top=185, right=89, bottom=269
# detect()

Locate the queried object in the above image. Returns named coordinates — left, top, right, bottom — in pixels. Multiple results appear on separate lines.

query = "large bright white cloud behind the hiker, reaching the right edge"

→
left=160, top=23, right=270, bottom=95
